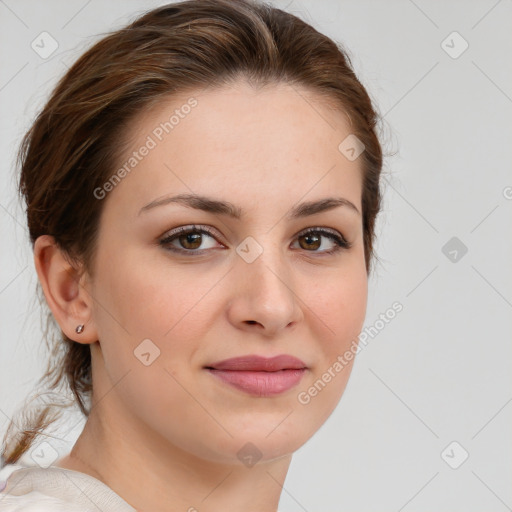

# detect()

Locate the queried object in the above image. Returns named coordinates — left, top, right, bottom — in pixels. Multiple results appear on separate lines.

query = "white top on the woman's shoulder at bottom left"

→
left=0, top=464, right=137, bottom=512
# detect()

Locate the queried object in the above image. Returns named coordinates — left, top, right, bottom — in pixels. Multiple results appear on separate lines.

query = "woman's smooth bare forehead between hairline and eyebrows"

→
left=106, top=82, right=361, bottom=220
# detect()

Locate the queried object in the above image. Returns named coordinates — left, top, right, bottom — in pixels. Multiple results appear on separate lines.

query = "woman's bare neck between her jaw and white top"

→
left=60, top=348, right=291, bottom=512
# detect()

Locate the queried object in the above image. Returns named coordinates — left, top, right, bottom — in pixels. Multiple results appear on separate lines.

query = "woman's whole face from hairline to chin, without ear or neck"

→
left=86, top=82, right=367, bottom=463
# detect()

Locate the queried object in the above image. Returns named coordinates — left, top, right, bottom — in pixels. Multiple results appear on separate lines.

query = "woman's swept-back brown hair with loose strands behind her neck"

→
left=2, top=0, right=383, bottom=464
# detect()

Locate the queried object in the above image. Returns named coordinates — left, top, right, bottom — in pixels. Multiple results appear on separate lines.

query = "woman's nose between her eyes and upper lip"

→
left=228, top=249, right=303, bottom=337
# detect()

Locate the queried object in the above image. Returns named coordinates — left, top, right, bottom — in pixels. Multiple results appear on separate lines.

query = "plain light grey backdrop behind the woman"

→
left=0, top=0, right=512, bottom=512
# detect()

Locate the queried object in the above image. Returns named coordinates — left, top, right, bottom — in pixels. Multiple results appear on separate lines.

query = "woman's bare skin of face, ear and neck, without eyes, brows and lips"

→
left=34, top=81, right=367, bottom=512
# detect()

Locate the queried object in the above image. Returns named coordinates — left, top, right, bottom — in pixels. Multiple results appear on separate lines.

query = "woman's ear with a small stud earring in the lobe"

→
left=34, top=235, right=98, bottom=344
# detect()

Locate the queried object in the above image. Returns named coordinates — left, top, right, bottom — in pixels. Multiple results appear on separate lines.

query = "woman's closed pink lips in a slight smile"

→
left=205, top=355, right=307, bottom=396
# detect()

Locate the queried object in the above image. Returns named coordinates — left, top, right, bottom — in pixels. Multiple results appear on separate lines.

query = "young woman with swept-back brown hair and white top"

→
left=0, top=0, right=382, bottom=511
